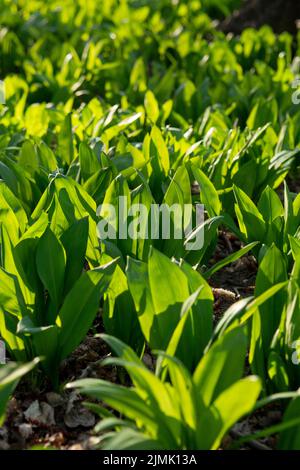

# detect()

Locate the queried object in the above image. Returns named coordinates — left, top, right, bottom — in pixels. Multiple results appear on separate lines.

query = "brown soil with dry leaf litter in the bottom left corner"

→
left=0, top=335, right=118, bottom=450
